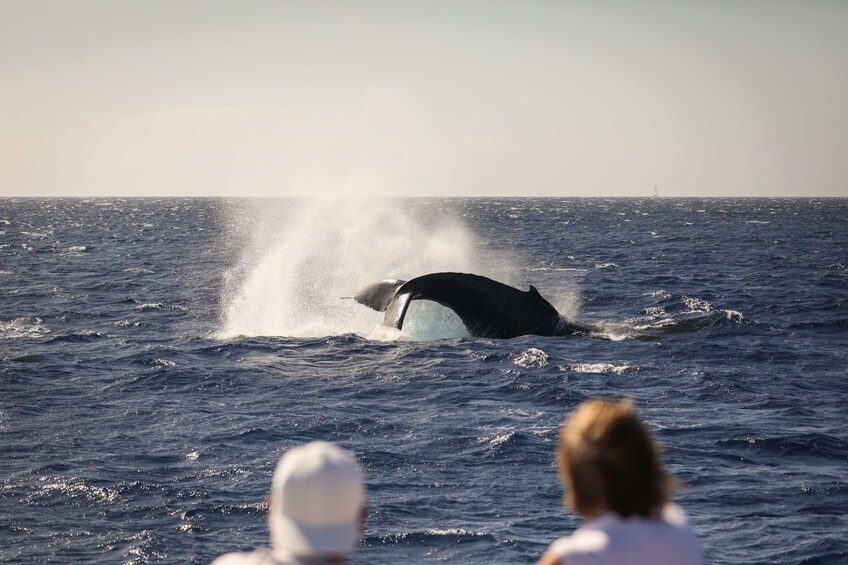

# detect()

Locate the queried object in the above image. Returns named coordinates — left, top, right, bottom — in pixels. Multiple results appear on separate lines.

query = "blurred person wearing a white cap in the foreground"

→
left=212, top=441, right=366, bottom=565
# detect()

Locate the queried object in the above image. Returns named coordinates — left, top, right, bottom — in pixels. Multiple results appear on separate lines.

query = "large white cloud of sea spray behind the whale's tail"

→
left=219, top=198, right=486, bottom=339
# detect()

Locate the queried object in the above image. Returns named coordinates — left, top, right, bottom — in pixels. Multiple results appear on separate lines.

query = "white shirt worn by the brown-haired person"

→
left=549, top=504, right=704, bottom=565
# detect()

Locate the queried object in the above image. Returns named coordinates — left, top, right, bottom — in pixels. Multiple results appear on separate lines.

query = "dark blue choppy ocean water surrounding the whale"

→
left=0, top=199, right=848, bottom=563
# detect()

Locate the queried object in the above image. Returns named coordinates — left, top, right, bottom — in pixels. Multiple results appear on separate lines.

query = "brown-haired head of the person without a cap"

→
left=557, top=400, right=672, bottom=518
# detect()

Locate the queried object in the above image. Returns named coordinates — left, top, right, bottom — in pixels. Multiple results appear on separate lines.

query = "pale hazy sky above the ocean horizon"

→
left=0, top=0, right=848, bottom=197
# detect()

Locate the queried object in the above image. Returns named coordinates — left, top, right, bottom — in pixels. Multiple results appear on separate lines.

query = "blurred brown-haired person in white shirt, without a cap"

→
left=539, top=400, right=703, bottom=565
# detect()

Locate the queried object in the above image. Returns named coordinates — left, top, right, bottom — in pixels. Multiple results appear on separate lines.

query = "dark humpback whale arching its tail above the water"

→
left=353, top=272, right=591, bottom=339
